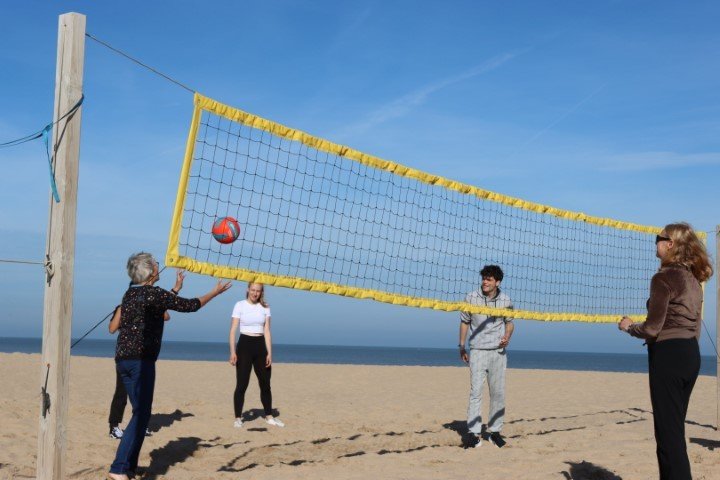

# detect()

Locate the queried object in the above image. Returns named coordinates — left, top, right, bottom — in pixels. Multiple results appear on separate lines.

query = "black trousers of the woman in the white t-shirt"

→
left=234, top=335, right=272, bottom=418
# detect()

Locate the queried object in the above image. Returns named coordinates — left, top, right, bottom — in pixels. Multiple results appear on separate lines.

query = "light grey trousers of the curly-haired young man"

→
left=467, top=349, right=507, bottom=435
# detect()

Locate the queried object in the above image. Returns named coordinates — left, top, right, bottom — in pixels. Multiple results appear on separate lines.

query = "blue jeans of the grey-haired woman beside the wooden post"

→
left=110, top=360, right=155, bottom=474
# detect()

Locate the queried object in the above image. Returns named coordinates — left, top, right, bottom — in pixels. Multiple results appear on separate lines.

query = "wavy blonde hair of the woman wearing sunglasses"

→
left=662, top=222, right=713, bottom=282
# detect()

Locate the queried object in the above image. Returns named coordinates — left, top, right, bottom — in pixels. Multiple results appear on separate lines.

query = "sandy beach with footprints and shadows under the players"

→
left=0, top=353, right=720, bottom=480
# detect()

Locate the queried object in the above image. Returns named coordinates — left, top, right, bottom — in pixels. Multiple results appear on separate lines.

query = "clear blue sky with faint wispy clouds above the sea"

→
left=0, top=1, right=720, bottom=354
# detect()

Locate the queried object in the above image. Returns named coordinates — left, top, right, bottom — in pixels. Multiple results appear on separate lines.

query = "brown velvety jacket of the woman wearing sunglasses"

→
left=628, top=263, right=703, bottom=343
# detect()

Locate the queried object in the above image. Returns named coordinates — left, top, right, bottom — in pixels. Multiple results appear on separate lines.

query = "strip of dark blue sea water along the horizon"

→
left=0, top=337, right=716, bottom=376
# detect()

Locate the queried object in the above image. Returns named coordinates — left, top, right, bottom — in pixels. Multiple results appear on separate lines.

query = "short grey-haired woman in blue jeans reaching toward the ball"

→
left=109, top=252, right=231, bottom=480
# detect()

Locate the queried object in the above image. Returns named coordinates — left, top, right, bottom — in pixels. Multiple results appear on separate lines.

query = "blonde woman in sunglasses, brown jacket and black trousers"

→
left=618, top=223, right=713, bottom=480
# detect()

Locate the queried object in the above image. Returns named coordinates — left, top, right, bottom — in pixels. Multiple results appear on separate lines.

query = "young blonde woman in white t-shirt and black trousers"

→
left=230, top=283, right=285, bottom=428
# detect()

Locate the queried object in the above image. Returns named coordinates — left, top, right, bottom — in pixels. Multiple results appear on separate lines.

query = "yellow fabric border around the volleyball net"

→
left=165, top=93, right=704, bottom=323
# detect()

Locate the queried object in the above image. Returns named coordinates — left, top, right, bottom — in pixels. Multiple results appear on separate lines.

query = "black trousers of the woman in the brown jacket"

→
left=648, top=338, right=700, bottom=480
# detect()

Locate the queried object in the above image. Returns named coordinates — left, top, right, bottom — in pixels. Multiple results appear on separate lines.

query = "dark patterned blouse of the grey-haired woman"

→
left=115, top=285, right=200, bottom=360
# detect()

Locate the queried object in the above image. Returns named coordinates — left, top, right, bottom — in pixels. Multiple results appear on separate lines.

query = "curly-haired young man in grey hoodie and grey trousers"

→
left=458, top=265, right=515, bottom=447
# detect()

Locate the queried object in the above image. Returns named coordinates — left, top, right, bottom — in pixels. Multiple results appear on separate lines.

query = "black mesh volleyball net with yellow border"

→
left=165, top=94, right=680, bottom=322
